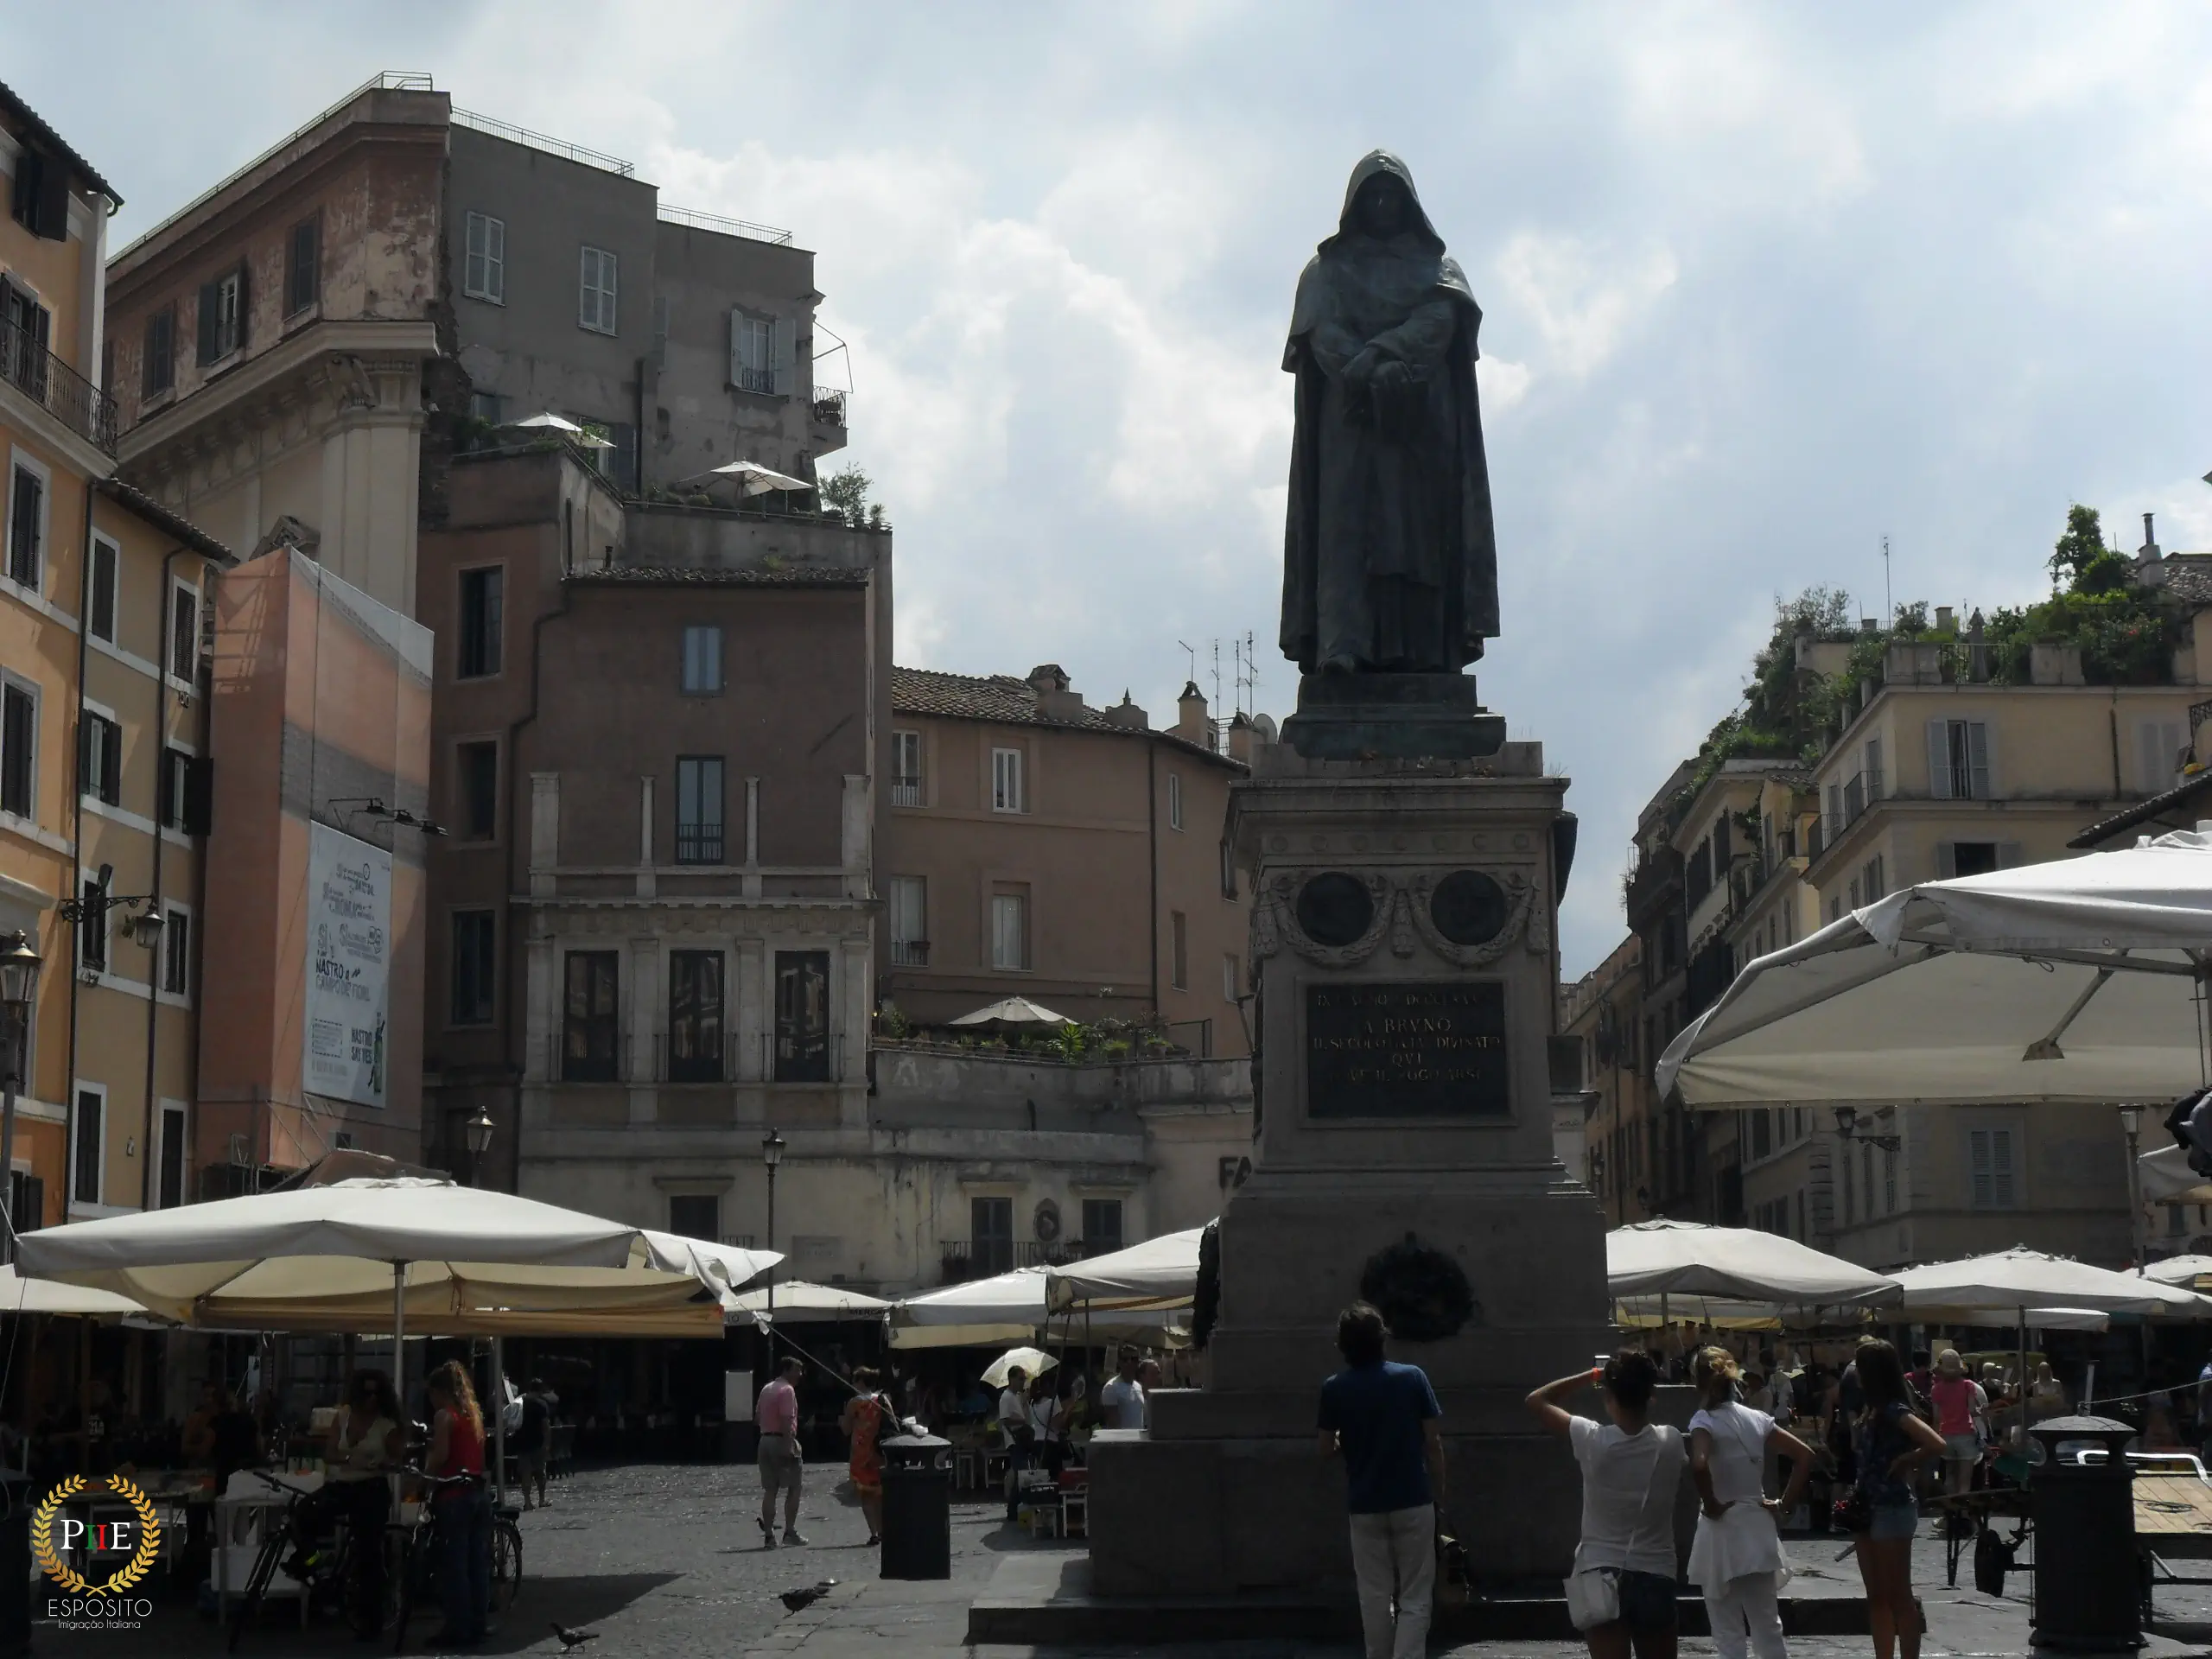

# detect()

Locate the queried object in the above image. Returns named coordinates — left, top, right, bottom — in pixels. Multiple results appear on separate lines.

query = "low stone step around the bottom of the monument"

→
left=967, top=1553, right=1872, bottom=1648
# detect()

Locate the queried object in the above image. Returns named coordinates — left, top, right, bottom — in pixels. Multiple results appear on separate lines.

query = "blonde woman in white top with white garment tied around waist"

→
left=1690, top=1347, right=1814, bottom=1659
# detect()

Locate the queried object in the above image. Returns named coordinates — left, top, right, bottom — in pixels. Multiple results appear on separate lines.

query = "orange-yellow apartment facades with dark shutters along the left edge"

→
left=0, top=86, right=230, bottom=1228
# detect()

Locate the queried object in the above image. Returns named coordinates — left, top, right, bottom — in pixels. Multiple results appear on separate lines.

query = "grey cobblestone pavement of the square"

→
left=38, top=1465, right=2212, bottom=1659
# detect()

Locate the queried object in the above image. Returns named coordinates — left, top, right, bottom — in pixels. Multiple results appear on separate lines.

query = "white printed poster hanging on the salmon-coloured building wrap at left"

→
left=303, top=823, right=391, bottom=1106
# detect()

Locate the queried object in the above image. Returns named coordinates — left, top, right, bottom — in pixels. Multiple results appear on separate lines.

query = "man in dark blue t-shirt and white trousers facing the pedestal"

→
left=1320, top=1303, right=1445, bottom=1659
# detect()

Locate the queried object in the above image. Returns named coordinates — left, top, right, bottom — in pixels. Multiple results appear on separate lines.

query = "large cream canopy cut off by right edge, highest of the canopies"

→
left=1656, top=830, right=2212, bottom=1110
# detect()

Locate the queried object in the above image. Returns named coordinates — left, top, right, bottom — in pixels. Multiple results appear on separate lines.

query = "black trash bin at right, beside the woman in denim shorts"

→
left=2029, top=1418, right=2144, bottom=1652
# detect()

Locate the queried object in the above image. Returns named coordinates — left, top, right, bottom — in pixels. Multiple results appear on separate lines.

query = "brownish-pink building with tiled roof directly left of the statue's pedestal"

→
left=880, top=664, right=1261, bottom=1058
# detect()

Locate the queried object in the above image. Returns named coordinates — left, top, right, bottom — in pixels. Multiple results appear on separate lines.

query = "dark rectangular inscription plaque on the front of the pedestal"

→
left=1305, top=980, right=1513, bottom=1117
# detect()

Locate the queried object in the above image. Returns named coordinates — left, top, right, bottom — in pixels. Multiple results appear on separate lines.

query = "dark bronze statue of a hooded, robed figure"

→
left=1283, top=150, right=1497, bottom=675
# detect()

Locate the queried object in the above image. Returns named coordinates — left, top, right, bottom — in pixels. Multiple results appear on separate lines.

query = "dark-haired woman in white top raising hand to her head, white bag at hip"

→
left=1529, top=1350, right=1688, bottom=1659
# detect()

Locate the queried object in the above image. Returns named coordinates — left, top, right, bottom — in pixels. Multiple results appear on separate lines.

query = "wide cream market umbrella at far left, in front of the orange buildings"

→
left=17, top=1179, right=779, bottom=1336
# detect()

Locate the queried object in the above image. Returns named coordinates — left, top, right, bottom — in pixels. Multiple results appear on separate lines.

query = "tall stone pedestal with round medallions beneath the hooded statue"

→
left=1090, top=743, right=1612, bottom=1595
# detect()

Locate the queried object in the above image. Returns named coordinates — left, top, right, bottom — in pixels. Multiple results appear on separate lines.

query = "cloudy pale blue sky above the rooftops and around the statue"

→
left=17, top=0, right=2212, bottom=978
